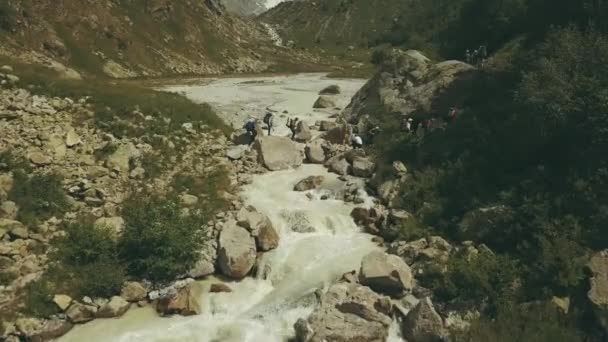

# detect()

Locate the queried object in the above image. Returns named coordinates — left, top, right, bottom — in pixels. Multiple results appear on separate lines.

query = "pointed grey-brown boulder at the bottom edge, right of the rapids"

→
left=402, top=297, right=446, bottom=342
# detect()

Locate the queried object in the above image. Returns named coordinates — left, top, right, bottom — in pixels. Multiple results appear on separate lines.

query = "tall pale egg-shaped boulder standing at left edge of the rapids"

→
left=218, top=222, right=256, bottom=279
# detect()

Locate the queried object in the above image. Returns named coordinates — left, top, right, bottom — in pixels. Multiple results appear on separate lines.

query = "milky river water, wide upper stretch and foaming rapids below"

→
left=60, top=75, right=401, bottom=342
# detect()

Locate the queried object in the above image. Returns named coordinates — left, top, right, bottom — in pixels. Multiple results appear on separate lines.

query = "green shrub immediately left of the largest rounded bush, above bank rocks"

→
left=50, top=219, right=125, bottom=297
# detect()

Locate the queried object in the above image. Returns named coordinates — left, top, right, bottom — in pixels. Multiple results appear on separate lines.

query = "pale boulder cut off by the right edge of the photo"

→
left=587, top=250, right=608, bottom=333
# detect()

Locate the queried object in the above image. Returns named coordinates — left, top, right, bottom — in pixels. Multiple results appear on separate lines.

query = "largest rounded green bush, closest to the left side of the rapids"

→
left=119, top=194, right=205, bottom=281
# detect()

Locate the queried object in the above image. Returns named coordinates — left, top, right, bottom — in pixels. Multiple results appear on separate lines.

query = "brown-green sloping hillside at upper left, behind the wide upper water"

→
left=0, top=0, right=324, bottom=78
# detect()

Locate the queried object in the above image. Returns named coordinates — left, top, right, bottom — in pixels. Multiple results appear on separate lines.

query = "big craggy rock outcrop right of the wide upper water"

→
left=343, top=50, right=477, bottom=125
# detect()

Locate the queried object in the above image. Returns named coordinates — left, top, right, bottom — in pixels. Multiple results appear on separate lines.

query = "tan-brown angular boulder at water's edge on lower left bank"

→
left=156, top=282, right=203, bottom=316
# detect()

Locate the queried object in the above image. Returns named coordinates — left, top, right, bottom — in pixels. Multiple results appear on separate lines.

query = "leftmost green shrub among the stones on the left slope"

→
left=8, top=170, right=69, bottom=225
